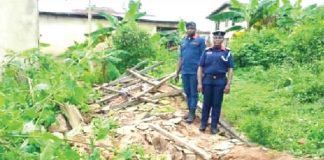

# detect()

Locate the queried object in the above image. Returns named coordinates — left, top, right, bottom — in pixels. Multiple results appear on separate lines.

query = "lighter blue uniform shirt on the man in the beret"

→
left=180, top=36, right=206, bottom=74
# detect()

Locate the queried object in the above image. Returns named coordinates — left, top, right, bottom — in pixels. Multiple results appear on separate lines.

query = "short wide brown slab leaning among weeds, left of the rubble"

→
left=60, top=104, right=84, bottom=129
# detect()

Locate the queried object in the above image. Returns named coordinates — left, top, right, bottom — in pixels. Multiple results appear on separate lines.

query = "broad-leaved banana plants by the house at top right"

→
left=208, top=0, right=315, bottom=31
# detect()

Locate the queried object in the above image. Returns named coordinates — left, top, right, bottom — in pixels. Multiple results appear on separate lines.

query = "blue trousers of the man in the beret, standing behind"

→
left=181, top=74, right=198, bottom=111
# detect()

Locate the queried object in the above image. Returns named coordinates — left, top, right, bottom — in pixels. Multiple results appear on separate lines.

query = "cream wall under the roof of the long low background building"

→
left=39, top=14, right=175, bottom=55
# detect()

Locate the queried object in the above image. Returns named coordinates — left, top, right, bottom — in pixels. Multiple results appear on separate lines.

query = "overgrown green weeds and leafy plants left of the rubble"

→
left=0, top=1, right=162, bottom=160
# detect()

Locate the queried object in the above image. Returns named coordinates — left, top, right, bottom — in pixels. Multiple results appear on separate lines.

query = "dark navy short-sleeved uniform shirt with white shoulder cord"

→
left=199, top=48, right=234, bottom=74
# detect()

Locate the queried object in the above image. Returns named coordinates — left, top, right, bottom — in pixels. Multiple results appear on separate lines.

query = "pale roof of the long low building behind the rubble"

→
left=39, top=1, right=180, bottom=24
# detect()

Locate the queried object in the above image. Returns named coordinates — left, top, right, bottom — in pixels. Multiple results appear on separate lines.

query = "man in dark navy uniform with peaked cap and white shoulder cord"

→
left=197, top=31, right=234, bottom=134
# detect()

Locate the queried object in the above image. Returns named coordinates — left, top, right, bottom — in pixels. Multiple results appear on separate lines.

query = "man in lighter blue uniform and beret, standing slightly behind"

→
left=175, top=22, right=206, bottom=123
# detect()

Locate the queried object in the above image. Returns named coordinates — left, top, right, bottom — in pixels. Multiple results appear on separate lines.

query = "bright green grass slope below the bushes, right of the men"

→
left=223, top=70, right=324, bottom=157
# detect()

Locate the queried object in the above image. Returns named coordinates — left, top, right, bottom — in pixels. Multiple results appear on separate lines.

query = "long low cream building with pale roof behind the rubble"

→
left=39, top=2, right=179, bottom=54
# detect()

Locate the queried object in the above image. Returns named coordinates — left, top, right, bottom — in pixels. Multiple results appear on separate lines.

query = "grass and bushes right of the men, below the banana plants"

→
left=224, top=4, right=324, bottom=157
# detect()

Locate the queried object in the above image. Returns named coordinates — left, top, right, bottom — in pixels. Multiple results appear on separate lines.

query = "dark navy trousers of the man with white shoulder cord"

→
left=201, top=83, right=225, bottom=129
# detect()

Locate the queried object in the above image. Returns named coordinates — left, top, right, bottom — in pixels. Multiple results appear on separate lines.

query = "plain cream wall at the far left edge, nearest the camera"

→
left=0, top=0, right=39, bottom=60
